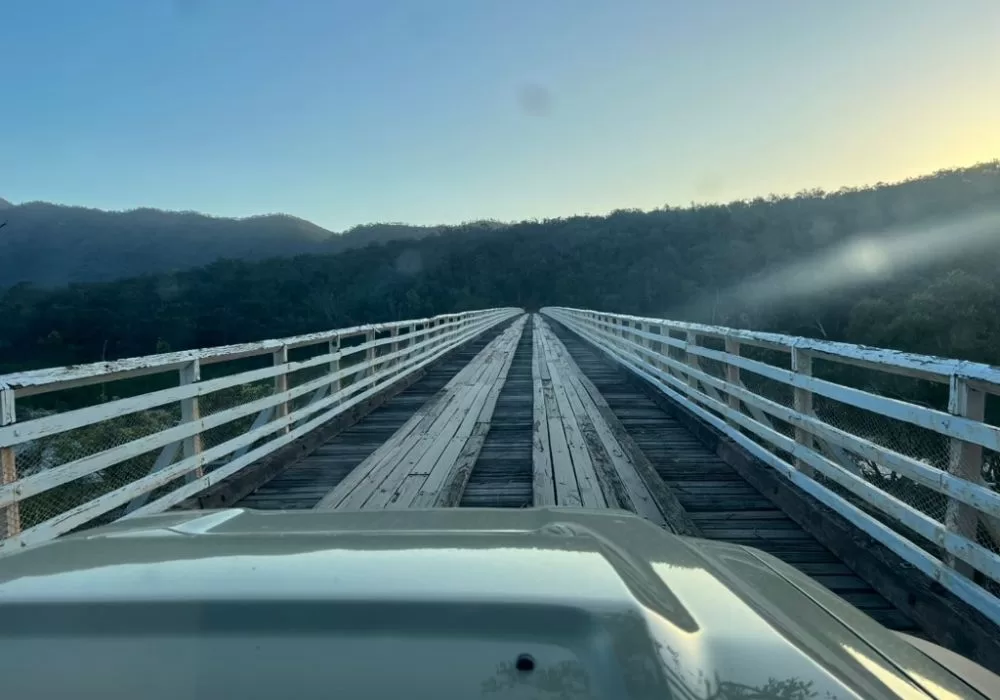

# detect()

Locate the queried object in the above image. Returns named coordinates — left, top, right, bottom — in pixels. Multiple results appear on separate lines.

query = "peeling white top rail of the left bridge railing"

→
left=0, top=308, right=506, bottom=396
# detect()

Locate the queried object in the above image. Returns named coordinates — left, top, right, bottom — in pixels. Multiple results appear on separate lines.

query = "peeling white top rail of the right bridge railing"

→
left=552, top=307, right=1000, bottom=392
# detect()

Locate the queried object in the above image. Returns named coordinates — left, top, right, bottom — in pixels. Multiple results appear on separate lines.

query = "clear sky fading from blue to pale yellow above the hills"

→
left=0, top=0, right=1000, bottom=230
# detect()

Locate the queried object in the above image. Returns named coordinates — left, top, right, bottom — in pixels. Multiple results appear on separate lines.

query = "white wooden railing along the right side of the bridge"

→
left=542, top=307, right=1000, bottom=623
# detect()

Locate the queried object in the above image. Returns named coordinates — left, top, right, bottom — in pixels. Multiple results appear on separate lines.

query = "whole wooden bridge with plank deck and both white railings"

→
left=0, top=308, right=1000, bottom=670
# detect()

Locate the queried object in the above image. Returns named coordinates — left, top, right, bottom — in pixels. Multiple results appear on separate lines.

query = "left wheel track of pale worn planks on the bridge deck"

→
left=315, top=316, right=527, bottom=510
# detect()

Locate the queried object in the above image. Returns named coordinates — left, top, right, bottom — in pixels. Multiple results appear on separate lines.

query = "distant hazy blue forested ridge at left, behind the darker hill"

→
left=0, top=199, right=446, bottom=287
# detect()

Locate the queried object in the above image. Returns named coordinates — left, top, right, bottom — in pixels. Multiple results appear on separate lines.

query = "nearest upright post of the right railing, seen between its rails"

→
left=945, top=375, right=986, bottom=578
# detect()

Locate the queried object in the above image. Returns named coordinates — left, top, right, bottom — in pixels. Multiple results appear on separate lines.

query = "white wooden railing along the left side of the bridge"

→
left=0, top=308, right=522, bottom=551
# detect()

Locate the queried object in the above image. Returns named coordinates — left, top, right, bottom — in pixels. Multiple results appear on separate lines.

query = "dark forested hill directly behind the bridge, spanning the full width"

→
left=0, top=163, right=1000, bottom=378
